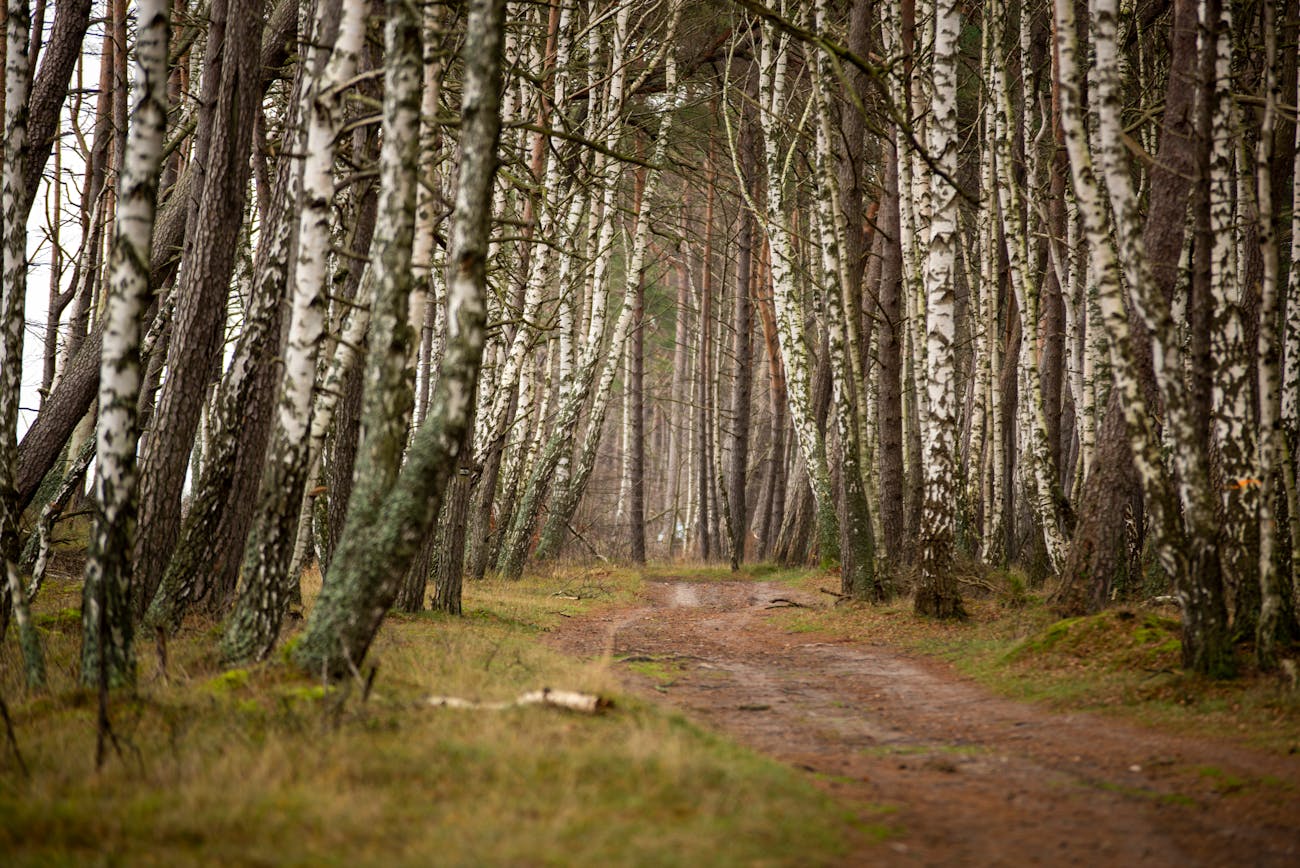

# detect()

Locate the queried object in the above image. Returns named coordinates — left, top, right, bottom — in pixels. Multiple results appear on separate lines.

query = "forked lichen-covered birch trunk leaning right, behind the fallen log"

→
left=294, top=0, right=506, bottom=677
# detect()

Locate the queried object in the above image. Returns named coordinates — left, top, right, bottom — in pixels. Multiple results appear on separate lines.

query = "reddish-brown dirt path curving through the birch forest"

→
left=555, top=581, right=1300, bottom=865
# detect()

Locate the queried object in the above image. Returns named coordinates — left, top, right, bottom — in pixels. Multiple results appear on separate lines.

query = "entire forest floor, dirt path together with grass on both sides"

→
left=0, top=563, right=1300, bottom=867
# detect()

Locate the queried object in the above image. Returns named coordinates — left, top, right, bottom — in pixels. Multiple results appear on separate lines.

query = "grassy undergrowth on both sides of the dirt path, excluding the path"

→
left=0, top=565, right=1300, bottom=864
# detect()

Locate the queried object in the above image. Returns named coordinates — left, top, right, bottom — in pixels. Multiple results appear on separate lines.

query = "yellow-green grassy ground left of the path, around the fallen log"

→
left=0, top=570, right=857, bottom=865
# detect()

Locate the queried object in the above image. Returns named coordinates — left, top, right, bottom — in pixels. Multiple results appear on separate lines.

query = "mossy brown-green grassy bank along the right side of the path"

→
left=772, top=572, right=1300, bottom=754
